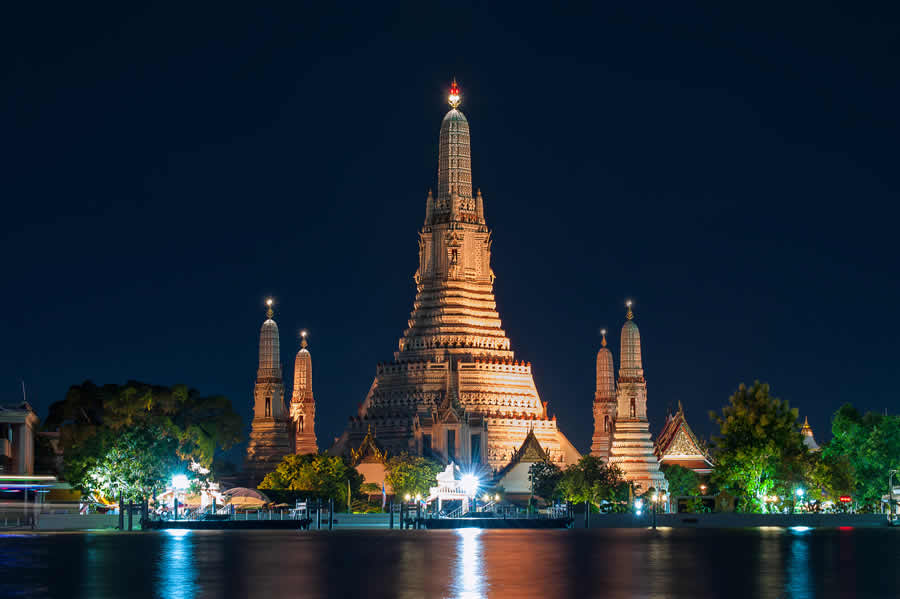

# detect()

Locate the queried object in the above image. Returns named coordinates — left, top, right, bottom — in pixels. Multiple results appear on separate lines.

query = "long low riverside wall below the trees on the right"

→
left=574, top=512, right=887, bottom=528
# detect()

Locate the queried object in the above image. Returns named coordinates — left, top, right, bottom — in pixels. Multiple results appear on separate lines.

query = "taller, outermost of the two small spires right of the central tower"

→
left=609, top=301, right=668, bottom=493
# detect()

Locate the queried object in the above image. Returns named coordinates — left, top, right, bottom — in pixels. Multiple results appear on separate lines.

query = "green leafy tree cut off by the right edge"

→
left=822, top=404, right=900, bottom=507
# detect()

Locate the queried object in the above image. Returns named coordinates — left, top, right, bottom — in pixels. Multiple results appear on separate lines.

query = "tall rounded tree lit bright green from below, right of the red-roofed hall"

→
left=710, top=381, right=807, bottom=511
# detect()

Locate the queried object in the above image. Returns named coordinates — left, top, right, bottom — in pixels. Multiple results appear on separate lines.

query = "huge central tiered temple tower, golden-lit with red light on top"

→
left=331, top=81, right=579, bottom=470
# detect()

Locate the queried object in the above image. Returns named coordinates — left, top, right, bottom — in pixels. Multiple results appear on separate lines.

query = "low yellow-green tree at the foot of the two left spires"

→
left=259, top=453, right=363, bottom=511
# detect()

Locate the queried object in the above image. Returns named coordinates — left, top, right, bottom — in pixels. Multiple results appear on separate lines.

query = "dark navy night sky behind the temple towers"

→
left=0, top=3, right=900, bottom=460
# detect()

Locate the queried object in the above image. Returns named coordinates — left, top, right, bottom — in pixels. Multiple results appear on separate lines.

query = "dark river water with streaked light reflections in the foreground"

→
left=0, top=528, right=900, bottom=599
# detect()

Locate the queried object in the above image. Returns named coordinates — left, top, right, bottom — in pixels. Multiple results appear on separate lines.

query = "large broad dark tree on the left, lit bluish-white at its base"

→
left=44, top=381, right=242, bottom=499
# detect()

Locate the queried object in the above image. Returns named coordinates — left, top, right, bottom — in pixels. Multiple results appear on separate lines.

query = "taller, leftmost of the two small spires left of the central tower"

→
left=244, top=299, right=291, bottom=484
